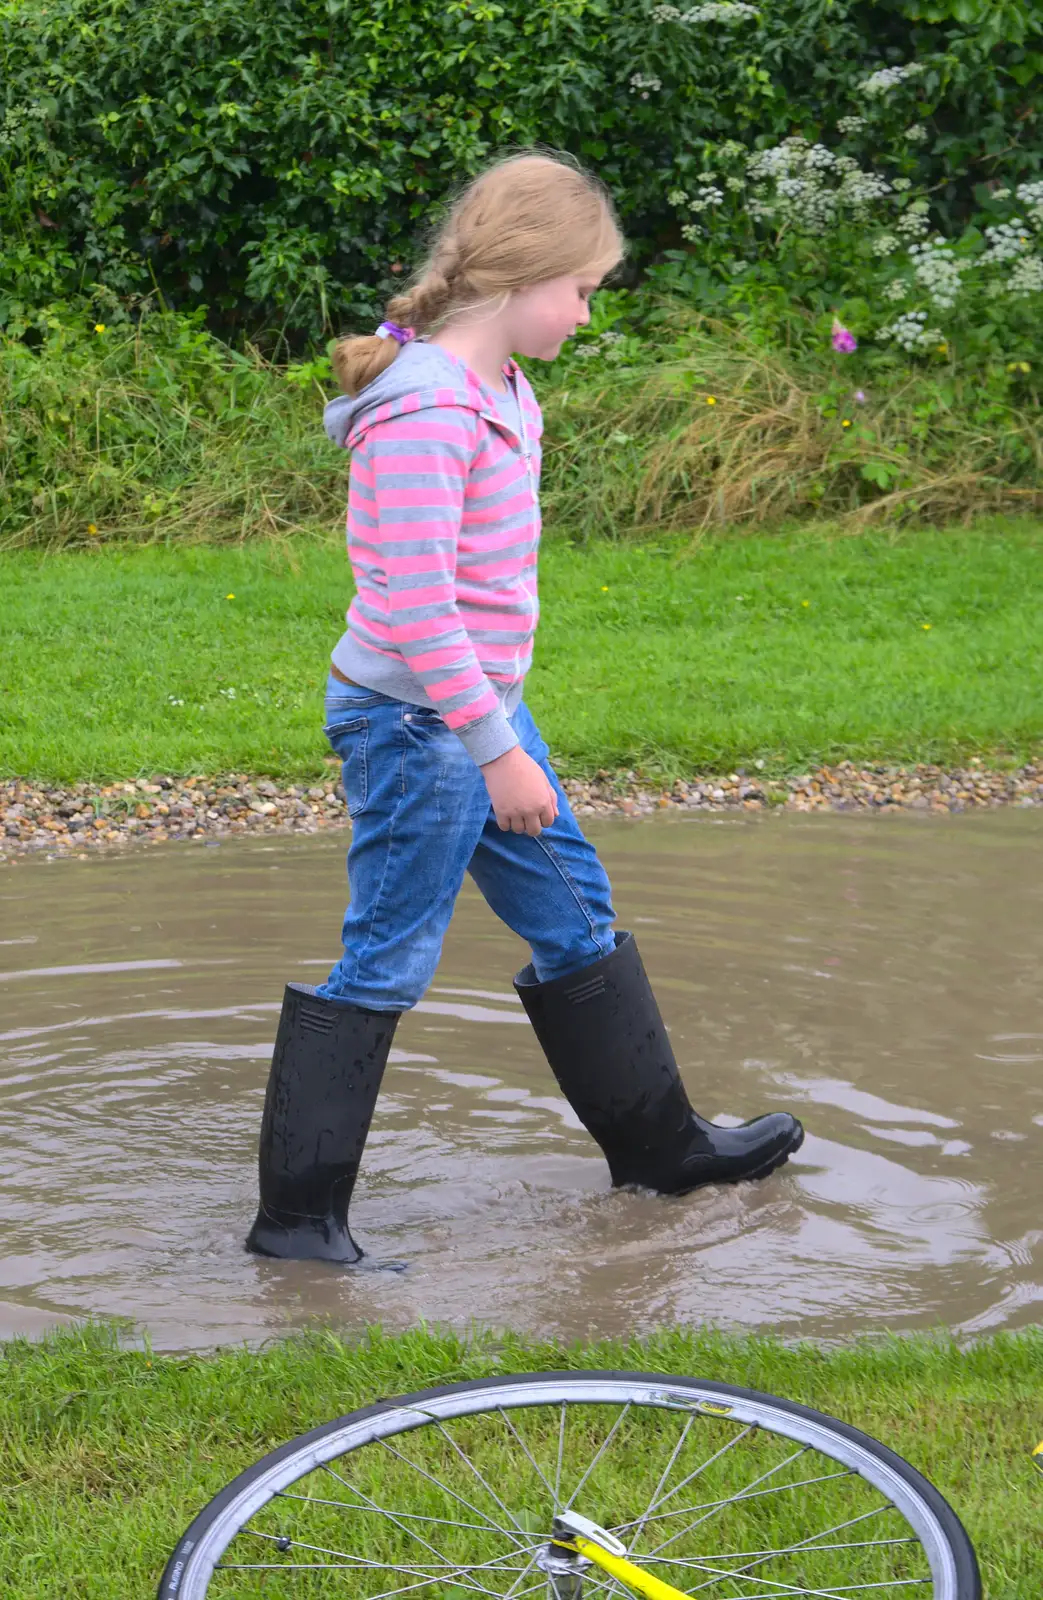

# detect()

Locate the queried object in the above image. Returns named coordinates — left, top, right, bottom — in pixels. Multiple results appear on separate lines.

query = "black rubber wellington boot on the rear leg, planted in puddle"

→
left=246, top=984, right=402, bottom=1262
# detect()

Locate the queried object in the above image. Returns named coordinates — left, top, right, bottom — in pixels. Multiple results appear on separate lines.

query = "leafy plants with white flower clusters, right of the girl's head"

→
left=648, top=106, right=1043, bottom=374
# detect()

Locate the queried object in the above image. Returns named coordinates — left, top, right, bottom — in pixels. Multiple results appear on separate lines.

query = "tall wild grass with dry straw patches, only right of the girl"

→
left=547, top=325, right=1043, bottom=534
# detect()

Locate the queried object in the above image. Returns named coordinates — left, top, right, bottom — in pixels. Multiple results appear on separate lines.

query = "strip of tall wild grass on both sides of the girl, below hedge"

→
left=0, top=304, right=1043, bottom=549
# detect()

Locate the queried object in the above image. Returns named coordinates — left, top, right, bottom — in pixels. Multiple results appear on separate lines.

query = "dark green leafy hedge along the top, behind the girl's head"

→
left=0, top=0, right=1043, bottom=341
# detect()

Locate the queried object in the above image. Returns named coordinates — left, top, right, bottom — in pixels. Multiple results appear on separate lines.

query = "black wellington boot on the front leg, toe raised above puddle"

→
left=514, top=933, right=805, bottom=1194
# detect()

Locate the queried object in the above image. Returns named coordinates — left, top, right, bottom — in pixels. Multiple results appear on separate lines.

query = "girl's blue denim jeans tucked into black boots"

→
left=318, top=675, right=616, bottom=1011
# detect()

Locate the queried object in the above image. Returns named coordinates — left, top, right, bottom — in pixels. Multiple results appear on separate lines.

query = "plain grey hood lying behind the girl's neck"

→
left=323, top=339, right=522, bottom=450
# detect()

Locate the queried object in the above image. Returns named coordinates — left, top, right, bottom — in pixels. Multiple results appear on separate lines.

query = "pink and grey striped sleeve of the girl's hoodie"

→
left=349, top=406, right=518, bottom=766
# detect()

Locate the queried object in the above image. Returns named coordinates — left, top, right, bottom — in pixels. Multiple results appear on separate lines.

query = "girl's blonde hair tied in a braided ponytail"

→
left=333, top=150, right=625, bottom=395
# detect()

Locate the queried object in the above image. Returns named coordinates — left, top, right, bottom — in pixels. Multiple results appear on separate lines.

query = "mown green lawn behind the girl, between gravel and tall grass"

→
left=0, top=520, right=1043, bottom=782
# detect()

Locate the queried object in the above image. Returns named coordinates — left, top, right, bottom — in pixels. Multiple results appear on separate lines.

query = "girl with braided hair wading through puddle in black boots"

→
left=248, top=152, right=803, bottom=1262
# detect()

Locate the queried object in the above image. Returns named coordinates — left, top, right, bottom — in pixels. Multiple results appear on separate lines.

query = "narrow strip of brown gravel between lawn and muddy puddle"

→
left=0, top=757, right=1043, bottom=861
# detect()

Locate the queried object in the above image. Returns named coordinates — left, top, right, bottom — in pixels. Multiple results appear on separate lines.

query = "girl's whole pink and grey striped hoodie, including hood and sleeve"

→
left=325, top=339, right=542, bottom=765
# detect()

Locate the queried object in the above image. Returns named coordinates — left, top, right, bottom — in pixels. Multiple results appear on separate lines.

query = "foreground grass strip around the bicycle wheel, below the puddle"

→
left=0, top=1326, right=1043, bottom=1600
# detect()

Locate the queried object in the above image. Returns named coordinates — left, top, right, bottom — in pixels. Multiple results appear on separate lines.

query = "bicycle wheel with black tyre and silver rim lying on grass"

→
left=158, top=1371, right=981, bottom=1600
